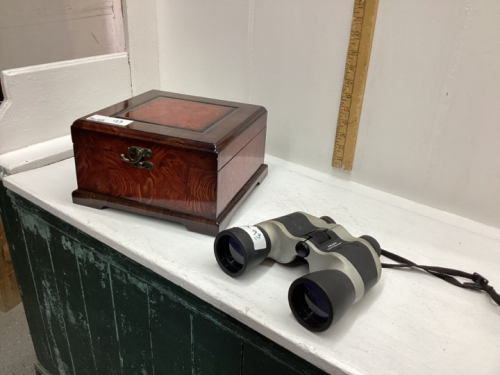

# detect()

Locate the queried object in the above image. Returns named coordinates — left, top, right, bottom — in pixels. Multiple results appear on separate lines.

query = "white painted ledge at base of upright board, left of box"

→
left=0, top=135, right=73, bottom=181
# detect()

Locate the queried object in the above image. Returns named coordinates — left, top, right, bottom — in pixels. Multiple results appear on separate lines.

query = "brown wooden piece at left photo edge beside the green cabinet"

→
left=0, top=216, right=21, bottom=312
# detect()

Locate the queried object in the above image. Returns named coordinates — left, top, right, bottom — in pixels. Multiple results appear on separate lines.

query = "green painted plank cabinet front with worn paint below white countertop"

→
left=0, top=186, right=325, bottom=375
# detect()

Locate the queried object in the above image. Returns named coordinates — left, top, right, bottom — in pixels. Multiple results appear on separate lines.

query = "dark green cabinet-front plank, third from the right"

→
left=149, top=288, right=192, bottom=375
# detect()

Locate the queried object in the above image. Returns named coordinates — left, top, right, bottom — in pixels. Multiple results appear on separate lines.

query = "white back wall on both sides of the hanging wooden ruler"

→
left=156, top=0, right=500, bottom=227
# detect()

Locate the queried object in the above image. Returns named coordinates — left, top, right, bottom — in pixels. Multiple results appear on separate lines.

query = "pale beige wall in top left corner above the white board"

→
left=0, top=0, right=125, bottom=71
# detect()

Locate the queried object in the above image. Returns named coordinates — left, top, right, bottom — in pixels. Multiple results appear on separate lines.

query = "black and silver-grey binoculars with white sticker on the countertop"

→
left=214, top=212, right=382, bottom=332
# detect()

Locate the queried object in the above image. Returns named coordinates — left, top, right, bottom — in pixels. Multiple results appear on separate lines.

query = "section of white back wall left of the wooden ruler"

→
left=157, top=0, right=353, bottom=169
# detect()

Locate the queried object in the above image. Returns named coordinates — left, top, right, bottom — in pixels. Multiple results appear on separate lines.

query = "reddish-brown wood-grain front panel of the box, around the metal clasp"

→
left=74, top=133, right=217, bottom=219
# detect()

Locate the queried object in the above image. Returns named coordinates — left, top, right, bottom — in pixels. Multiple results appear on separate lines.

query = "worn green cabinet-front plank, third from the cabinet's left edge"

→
left=50, top=235, right=97, bottom=375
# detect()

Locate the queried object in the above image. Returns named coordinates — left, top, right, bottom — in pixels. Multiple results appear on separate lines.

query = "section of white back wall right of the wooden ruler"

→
left=353, top=0, right=500, bottom=231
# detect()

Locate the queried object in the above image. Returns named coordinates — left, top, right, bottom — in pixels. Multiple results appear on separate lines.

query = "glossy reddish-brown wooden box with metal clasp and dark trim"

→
left=71, top=90, right=267, bottom=235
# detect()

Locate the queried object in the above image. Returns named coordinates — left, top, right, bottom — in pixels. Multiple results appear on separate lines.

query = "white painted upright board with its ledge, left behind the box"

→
left=0, top=52, right=132, bottom=174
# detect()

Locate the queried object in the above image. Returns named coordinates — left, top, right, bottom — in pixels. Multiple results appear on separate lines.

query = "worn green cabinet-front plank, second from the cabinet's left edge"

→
left=20, top=212, right=75, bottom=374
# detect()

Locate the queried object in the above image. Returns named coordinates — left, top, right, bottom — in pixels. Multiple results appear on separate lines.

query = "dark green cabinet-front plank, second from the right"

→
left=191, top=314, right=243, bottom=375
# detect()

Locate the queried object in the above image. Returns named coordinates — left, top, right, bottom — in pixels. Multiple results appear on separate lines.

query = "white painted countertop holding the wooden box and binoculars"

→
left=4, top=157, right=500, bottom=375
